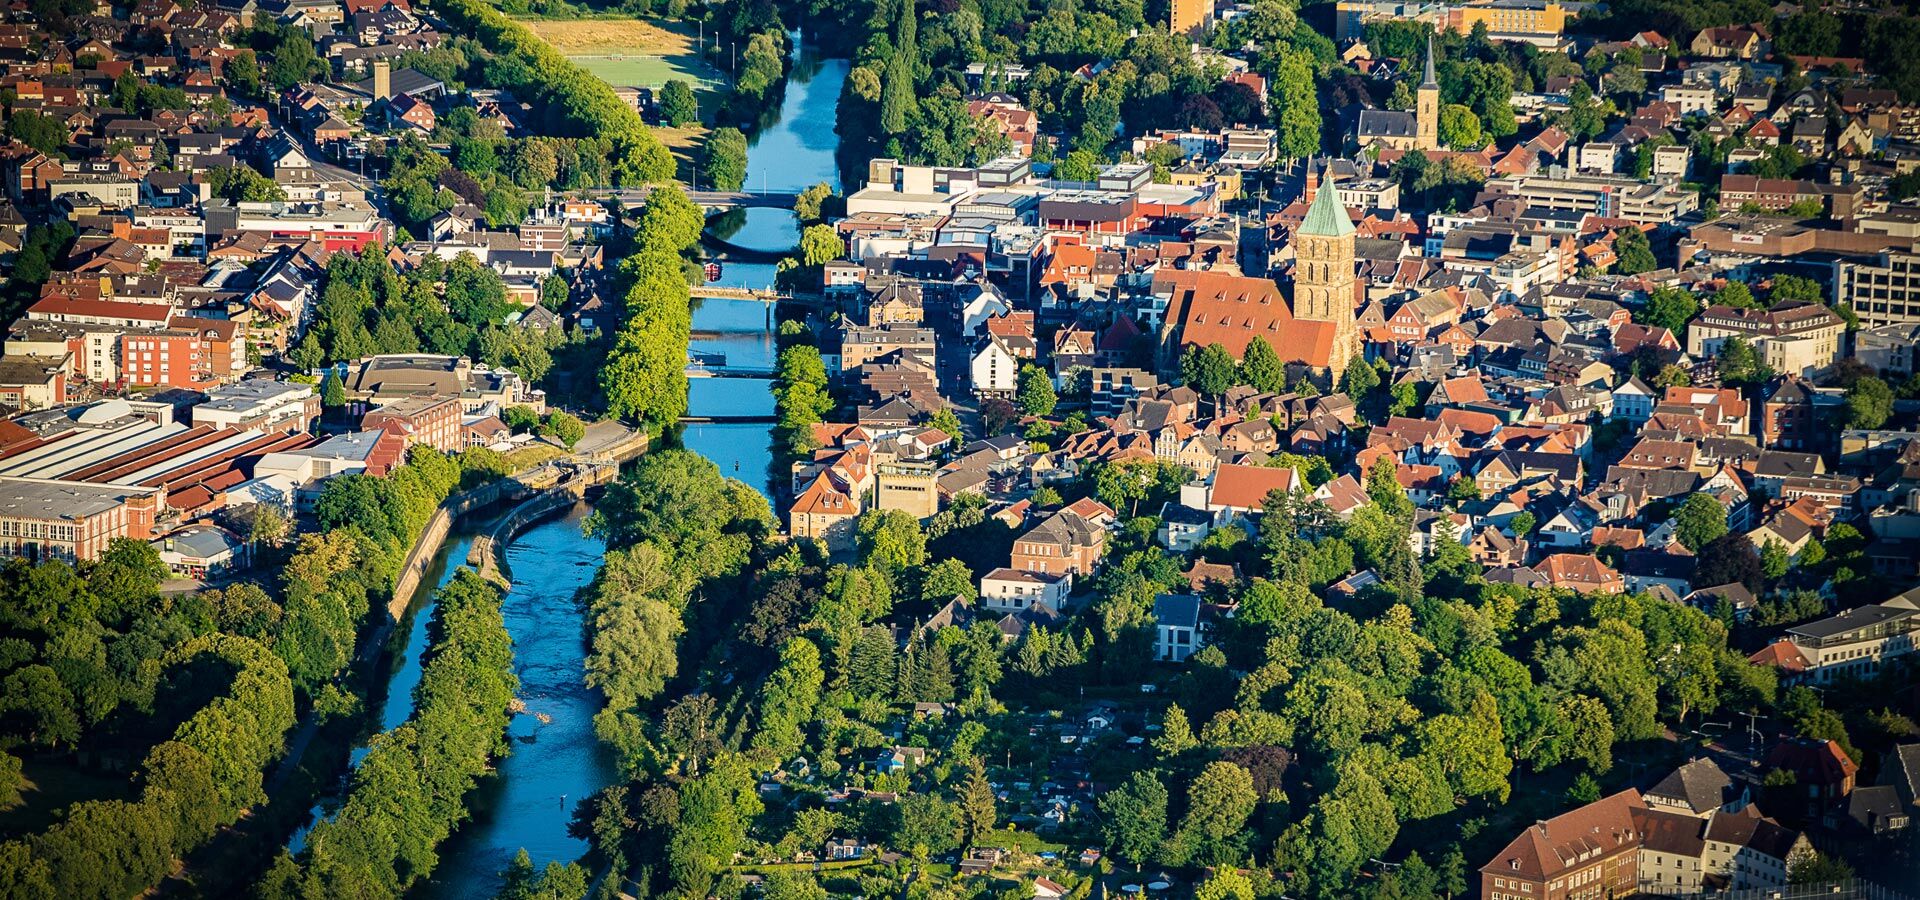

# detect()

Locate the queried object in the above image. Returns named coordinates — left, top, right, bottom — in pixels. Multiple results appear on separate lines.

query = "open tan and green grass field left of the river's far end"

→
left=522, top=19, right=726, bottom=150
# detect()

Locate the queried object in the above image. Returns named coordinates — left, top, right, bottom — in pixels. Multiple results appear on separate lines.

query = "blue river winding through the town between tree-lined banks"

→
left=407, top=35, right=847, bottom=898
